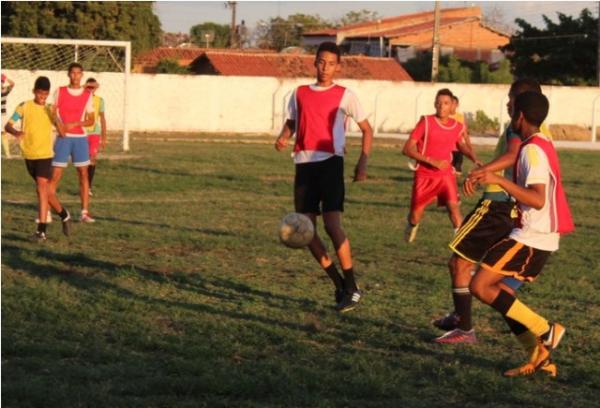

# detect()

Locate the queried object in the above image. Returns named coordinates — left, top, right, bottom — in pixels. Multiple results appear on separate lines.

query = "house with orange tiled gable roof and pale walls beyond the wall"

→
left=303, top=7, right=510, bottom=64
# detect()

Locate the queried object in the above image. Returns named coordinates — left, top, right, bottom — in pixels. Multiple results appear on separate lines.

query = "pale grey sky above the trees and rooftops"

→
left=154, top=1, right=598, bottom=33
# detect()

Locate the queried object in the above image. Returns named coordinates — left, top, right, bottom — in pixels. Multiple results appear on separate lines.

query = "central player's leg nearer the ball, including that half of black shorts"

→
left=294, top=159, right=344, bottom=304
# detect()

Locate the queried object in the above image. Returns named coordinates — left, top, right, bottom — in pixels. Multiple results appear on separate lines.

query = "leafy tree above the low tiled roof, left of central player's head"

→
left=255, top=13, right=332, bottom=50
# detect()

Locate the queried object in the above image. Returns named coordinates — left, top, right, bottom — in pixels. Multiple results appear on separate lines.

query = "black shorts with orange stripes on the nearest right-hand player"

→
left=481, top=238, right=552, bottom=282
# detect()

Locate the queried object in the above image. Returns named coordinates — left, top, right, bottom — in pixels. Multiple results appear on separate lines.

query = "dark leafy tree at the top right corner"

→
left=503, top=9, right=598, bottom=85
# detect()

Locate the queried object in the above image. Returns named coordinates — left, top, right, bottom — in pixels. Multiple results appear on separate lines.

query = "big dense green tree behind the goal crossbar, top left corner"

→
left=2, top=1, right=161, bottom=55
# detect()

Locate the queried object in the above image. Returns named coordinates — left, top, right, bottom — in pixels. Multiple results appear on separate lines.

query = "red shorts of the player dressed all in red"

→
left=410, top=173, right=460, bottom=211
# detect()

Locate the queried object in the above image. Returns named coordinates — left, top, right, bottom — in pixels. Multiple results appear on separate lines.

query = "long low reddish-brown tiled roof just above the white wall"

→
left=134, top=48, right=412, bottom=81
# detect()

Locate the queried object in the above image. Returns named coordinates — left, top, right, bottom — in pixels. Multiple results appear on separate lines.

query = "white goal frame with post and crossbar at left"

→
left=0, top=37, right=131, bottom=152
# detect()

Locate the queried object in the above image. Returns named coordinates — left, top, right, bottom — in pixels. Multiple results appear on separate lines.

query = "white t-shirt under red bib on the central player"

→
left=286, top=84, right=367, bottom=163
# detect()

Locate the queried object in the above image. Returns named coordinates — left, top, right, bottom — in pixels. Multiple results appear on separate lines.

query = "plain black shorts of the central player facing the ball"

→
left=294, top=156, right=345, bottom=214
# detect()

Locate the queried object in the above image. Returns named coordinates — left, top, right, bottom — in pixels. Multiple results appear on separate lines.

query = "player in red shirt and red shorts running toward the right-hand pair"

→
left=402, top=89, right=480, bottom=243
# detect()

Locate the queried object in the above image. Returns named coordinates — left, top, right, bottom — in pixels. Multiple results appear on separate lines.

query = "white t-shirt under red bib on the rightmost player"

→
left=510, top=137, right=560, bottom=251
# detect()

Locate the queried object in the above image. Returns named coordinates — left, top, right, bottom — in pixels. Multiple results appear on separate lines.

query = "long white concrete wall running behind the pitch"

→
left=6, top=71, right=600, bottom=133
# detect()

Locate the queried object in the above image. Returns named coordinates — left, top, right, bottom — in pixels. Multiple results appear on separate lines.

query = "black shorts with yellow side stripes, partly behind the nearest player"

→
left=448, top=200, right=517, bottom=263
